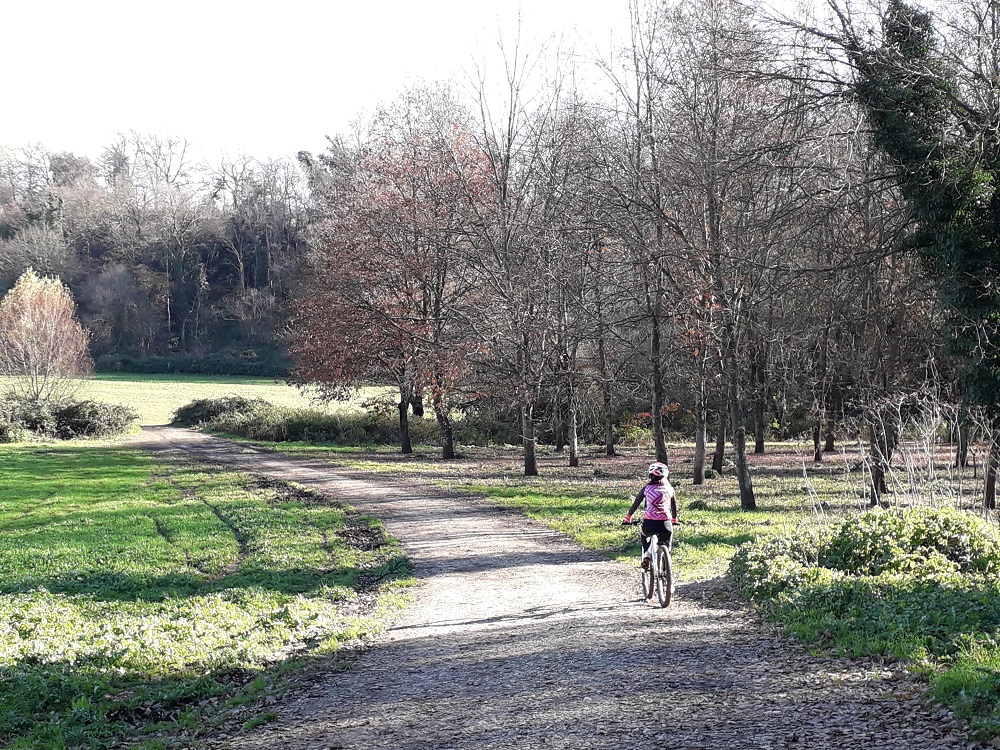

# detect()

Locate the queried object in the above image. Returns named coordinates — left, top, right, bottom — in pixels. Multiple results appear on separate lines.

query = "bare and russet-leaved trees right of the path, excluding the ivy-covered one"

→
left=294, top=0, right=996, bottom=509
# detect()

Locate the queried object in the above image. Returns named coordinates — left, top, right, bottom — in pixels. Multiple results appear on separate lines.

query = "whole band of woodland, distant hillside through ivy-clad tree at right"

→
left=0, top=0, right=1000, bottom=509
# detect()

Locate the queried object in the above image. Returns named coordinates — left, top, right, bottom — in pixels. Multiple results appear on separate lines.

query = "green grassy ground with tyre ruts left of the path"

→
left=0, top=444, right=408, bottom=748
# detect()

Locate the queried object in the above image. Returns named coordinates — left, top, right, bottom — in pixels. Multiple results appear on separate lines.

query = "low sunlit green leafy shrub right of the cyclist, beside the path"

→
left=731, top=506, right=1000, bottom=738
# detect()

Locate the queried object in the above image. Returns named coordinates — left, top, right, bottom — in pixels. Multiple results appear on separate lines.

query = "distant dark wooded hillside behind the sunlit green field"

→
left=0, top=134, right=309, bottom=375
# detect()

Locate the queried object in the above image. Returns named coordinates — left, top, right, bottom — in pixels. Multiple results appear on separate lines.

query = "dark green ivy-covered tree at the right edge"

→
left=844, top=0, right=1000, bottom=507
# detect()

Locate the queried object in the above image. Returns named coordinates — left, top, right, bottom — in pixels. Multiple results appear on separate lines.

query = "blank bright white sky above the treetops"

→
left=0, top=0, right=628, bottom=163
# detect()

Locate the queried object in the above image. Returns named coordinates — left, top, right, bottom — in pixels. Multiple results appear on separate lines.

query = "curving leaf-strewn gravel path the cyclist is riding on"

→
left=129, top=428, right=976, bottom=750
